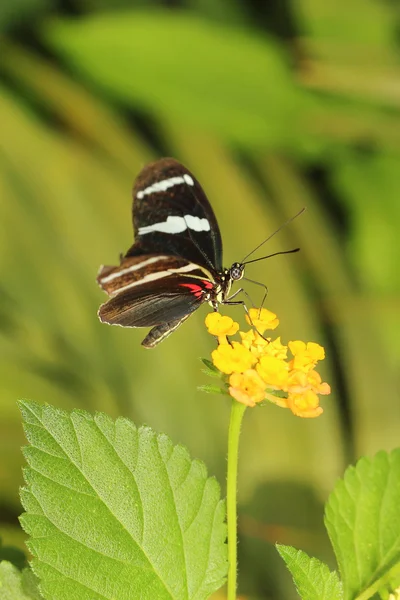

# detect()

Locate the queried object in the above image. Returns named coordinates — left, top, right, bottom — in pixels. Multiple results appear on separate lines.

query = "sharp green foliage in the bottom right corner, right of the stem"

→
left=278, top=449, right=400, bottom=600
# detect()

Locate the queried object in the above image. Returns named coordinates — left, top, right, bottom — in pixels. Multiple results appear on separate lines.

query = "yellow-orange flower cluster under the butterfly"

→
left=206, top=308, right=331, bottom=418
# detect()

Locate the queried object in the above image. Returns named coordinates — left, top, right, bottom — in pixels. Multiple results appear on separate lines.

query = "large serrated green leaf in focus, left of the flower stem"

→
left=20, top=402, right=227, bottom=600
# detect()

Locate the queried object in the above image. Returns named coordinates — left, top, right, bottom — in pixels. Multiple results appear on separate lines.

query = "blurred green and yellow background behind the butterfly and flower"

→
left=0, top=0, right=400, bottom=599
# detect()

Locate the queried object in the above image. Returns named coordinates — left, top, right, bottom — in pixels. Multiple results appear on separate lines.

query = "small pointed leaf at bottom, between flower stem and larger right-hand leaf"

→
left=276, top=544, right=343, bottom=600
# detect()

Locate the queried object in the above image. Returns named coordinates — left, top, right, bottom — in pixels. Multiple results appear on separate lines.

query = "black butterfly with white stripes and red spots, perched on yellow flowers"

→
left=97, top=158, right=298, bottom=348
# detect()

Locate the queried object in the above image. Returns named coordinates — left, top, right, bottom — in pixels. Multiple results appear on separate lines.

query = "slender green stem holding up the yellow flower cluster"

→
left=226, top=400, right=246, bottom=600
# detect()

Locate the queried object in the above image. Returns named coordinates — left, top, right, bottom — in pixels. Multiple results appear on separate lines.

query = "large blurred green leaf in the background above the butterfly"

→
left=45, top=10, right=308, bottom=145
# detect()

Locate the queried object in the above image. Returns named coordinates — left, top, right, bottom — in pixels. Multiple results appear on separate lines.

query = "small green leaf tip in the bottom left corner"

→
left=0, top=561, right=42, bottom=600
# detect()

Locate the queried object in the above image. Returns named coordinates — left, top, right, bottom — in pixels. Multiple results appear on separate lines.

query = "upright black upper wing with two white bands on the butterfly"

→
left=126, top=158, right=222, bottom=272
